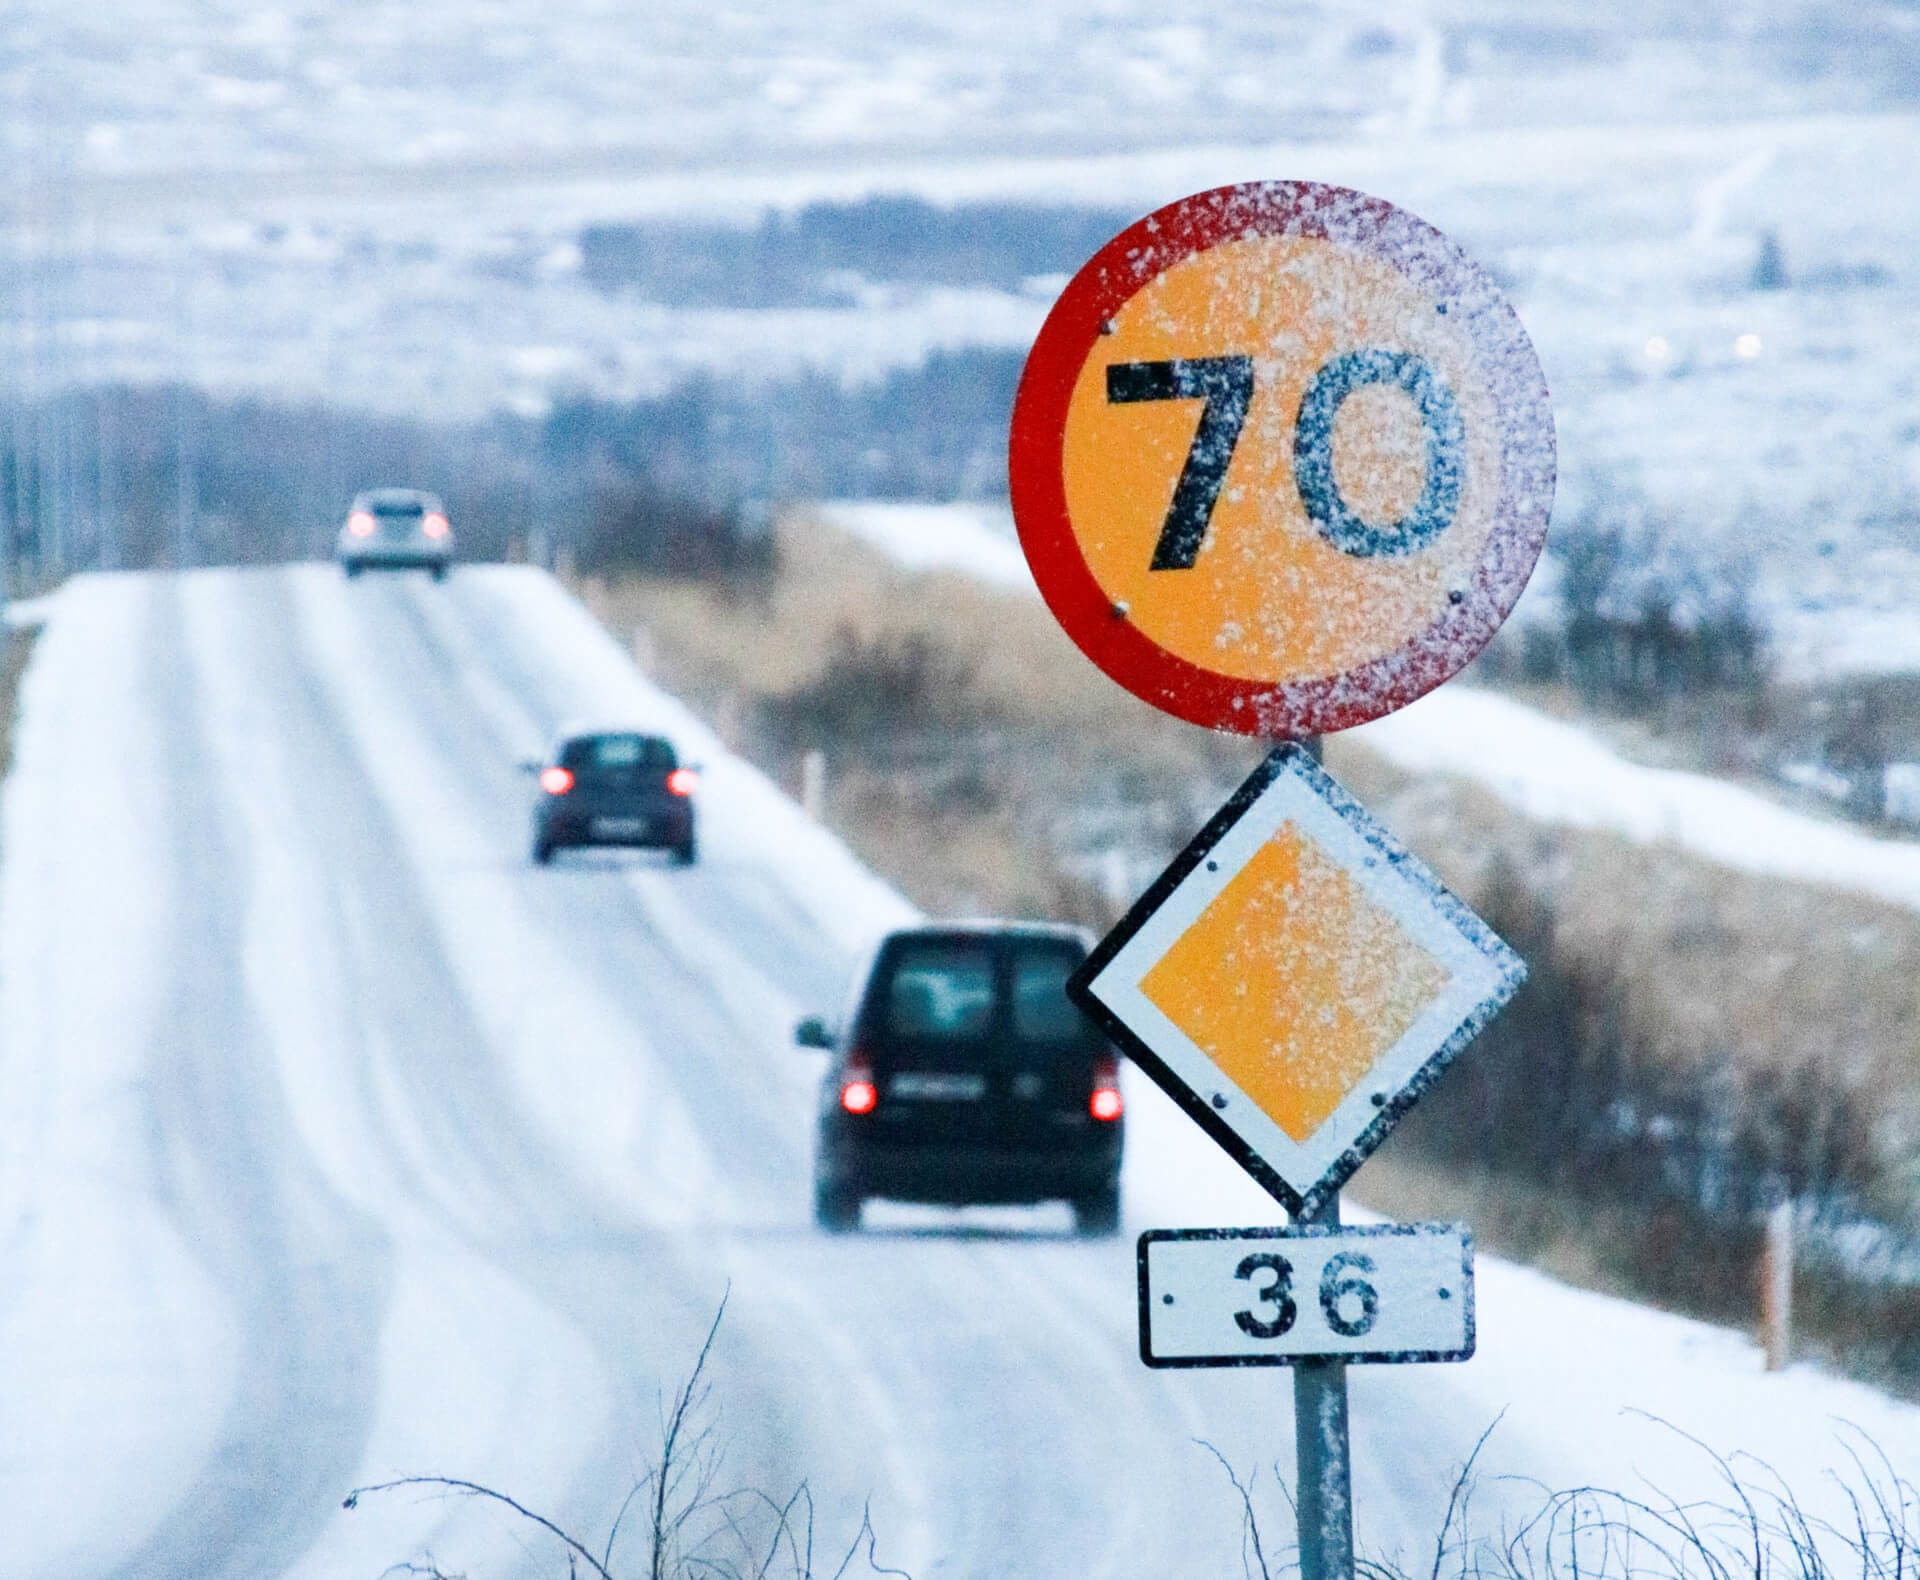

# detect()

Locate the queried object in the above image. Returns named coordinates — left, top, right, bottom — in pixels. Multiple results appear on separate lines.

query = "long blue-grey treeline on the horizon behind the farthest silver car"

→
left=0, top=351, right=1021, bottom=591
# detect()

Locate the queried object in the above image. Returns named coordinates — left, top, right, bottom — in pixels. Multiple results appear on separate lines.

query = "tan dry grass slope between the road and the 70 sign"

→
left=580, top=518, right=1260, bottom=925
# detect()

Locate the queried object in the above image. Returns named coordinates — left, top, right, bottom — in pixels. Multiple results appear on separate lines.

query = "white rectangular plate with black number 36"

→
left=1139, top=1223, right=1475, bottom=1367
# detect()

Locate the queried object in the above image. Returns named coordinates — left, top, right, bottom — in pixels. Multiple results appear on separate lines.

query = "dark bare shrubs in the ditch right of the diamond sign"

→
left=1396, top=858, right=1920, bottom=1328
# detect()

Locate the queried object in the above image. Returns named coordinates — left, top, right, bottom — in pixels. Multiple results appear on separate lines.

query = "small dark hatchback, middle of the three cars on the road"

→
left=526, top=730, right=697, bottom=866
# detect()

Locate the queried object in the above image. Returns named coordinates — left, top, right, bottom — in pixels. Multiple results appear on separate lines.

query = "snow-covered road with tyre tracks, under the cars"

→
left=0, top=566, right=1920, bottom=1580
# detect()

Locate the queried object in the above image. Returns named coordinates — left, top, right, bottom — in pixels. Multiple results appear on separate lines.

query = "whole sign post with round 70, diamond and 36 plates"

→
left=1008, top=180, right=1553, bottom=1580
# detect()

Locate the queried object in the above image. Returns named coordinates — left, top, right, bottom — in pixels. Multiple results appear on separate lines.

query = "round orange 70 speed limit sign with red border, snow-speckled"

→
left=1010, top=180, right=1553, bottom=737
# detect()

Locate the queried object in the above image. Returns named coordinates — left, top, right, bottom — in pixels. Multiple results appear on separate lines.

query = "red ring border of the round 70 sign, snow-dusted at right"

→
left=1008, top=180, right=1553, bottom=737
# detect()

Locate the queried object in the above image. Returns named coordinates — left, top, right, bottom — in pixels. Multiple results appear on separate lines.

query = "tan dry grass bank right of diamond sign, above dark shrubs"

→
left=1327, top=739, right=1920, bottom=1225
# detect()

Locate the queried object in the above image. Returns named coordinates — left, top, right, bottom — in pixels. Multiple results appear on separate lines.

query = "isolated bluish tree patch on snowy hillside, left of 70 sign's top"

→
left=580, top=198, right=1137, bottom=307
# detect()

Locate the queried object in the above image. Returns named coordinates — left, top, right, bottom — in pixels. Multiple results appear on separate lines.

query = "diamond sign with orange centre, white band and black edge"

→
left=1068, top=743, right=1526, bottom=1213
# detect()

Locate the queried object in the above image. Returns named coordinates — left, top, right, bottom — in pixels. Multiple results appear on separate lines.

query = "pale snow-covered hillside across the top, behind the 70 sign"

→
left=0, top=0, right=1920, bottom=668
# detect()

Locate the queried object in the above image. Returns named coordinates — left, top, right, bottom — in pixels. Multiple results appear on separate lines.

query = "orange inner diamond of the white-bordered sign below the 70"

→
left=1140, top=822, right=1448, bottom=1142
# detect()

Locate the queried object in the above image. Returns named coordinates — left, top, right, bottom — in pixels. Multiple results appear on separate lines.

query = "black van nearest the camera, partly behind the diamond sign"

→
left=795, top=922, right=1125, bottom=1234
